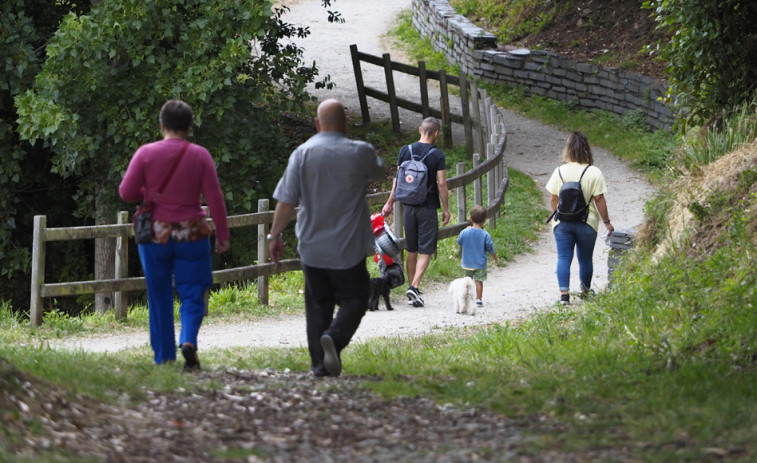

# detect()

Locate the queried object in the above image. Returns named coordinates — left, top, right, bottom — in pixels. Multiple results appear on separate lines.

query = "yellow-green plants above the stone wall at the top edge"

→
left=450, top=0, right=570, bottom=43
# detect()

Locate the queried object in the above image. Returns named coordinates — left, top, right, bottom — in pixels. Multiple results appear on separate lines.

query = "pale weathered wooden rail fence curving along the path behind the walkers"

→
left=29, top=59, right=509, bottom=326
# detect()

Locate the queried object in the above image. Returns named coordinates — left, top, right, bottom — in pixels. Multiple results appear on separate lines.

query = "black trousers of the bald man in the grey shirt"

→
left=302, top=259, right=370, bottom=374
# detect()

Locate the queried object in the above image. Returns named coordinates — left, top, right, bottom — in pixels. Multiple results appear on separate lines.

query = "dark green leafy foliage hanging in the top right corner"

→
left=644, top=0, right=757, bottom=124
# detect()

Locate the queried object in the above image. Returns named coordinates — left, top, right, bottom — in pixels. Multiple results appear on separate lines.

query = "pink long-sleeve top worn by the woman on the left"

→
left=118, top=139, right=229, bottom=241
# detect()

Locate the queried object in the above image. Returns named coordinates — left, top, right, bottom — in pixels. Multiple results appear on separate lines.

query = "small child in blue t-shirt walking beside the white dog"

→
left=457, top=205, right=497, bottom=307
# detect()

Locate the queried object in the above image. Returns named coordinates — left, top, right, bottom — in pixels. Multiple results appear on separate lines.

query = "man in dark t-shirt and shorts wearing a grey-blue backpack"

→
left=381, top=117, right=450, bottom=307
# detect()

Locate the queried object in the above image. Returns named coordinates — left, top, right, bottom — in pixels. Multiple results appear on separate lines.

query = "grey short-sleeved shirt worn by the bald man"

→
left=273, top=132, right=384, bottom=269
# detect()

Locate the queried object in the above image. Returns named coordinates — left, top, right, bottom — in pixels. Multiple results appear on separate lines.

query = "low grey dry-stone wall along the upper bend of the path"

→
left=412, top=0, right=674, bottom=128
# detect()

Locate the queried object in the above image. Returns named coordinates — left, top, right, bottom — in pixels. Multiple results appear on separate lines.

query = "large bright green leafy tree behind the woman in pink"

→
left=15, top=0, right=325, bottom=312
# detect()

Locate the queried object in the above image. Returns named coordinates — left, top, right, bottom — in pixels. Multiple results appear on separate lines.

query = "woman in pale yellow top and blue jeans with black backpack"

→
left=547, top=132, right=614, bottom=305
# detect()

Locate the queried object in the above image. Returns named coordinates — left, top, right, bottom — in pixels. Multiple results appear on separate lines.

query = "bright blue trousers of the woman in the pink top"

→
left=139, top=239, right=213, bottom=363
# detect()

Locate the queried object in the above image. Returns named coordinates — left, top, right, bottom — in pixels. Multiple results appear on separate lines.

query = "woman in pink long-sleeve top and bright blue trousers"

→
left=118, top=100, right=229, bottom=370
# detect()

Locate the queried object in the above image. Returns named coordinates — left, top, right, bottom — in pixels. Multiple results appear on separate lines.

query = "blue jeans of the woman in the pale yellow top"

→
left=554, top=222, right=597, bottom=291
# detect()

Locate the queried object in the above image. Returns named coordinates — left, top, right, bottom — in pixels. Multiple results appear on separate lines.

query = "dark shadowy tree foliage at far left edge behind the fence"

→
left=0, top=0, right=89, bottom=312
